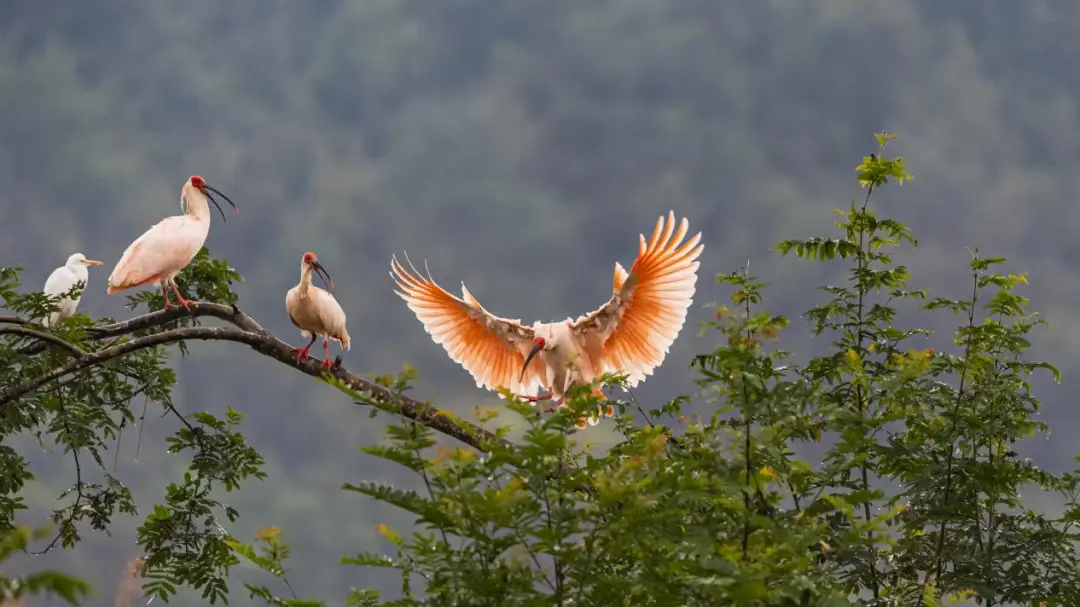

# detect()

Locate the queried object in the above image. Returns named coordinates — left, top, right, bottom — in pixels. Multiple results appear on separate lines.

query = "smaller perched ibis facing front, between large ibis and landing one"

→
left=285, top=252, right=351, bottom=368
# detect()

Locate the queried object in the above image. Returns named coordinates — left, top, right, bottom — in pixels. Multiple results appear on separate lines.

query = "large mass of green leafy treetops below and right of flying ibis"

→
left=232, top=133, right=1080, bottom=606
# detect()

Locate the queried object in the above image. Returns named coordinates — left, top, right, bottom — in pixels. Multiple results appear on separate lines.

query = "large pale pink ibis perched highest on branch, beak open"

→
left=107, top=175, right=240, bottom=310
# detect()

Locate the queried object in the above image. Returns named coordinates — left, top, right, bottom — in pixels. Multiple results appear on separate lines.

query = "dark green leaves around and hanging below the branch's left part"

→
left=0, top=247, right=262, bottom=602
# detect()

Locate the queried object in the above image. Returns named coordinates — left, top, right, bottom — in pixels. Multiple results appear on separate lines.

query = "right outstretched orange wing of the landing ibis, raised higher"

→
left=573, top=212, right=705, bottom=387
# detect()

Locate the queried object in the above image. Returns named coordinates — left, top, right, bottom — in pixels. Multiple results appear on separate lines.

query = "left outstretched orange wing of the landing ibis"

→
left=390, top=251, right=546, bottom=395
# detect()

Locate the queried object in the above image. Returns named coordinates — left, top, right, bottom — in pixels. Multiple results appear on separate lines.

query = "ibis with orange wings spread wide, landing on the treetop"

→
left=390, top=212, right=704, bottom=428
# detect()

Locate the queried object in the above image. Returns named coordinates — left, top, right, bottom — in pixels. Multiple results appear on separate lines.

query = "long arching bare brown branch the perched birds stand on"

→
left=0, top=302, right=505, bottom=451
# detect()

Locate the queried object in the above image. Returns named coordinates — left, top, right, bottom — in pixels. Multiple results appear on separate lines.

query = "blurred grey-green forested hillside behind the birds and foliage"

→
left=0, top=0, right=1080, bottom=605
